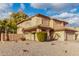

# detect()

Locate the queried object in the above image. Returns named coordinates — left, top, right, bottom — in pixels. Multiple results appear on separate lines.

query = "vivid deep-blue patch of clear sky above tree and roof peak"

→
left=12, top=3, right=46, bottom=16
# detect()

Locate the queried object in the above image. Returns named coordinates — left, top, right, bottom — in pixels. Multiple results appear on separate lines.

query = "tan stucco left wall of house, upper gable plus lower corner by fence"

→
left=17, top=17, right=42, bottom=34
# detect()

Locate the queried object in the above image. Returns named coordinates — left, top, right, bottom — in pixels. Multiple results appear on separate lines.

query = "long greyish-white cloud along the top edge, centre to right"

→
left=30, top=3, right=79, bottom=10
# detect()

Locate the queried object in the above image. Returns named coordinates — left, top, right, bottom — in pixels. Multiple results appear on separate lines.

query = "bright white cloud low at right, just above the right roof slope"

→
left=52, top=12, right=79, bottom=26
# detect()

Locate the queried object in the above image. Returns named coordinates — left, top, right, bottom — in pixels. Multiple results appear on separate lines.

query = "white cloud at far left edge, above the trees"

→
left=0, top=3, right=12, bottom=19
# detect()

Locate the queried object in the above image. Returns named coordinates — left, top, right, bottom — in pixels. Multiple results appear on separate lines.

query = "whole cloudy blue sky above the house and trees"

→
left=0, top=3, right=79, bottom=27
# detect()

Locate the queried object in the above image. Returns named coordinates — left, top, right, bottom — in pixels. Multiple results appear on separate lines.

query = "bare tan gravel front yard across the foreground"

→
left=0, top=41, right=79, bottom=56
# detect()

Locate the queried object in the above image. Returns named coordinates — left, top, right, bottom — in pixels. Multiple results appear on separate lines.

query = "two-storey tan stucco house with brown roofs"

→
left=17, top=14, right=76, bottom=41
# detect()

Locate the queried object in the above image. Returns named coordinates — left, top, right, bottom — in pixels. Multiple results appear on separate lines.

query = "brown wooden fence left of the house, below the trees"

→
left=0, top=33, right=24, bottom=41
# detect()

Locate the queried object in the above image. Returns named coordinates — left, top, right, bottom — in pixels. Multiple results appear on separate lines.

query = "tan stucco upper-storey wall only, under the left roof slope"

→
left=17, top=17, right=42, bottom=28
